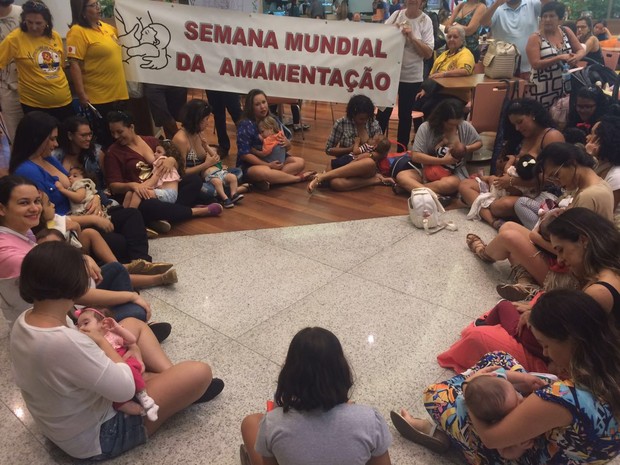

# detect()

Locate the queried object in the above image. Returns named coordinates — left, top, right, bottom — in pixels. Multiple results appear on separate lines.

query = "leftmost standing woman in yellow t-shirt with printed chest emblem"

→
left=0, top=1, right=74, bottom=120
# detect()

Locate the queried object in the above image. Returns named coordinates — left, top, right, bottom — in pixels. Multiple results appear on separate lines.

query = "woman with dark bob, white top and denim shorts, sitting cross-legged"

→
left=10, top=242, right=224, bottom=460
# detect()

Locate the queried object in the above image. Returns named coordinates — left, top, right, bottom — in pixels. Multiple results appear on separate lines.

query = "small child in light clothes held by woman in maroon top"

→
left=123, top=140, right=185, bottom=208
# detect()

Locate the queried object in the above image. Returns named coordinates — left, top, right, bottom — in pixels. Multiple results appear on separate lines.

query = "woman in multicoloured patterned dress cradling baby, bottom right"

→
left=392, top=290, right=620, bottom=465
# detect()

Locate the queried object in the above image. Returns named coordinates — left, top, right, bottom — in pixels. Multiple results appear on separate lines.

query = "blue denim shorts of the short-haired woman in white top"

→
left=89, top=412, right=148, bottom=461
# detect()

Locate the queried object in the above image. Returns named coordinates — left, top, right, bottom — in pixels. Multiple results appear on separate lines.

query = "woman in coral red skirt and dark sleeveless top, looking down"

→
left=437, top=208, right=620, bottom=371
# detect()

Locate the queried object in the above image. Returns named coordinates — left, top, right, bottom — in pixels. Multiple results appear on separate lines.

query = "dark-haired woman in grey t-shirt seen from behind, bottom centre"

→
left=241, top=328, right=392, bottom=465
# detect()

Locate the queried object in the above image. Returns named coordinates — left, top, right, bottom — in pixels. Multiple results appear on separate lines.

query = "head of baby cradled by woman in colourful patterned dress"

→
left=464, top=375, right=523, bottom=424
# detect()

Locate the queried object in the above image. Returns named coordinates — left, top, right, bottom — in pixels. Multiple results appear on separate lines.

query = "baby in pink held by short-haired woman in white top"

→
left=75, top=308, right=159, bottom=421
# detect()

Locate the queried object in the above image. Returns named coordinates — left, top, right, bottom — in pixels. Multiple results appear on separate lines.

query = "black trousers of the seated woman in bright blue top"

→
left=101, top=208, right=151, bottom=263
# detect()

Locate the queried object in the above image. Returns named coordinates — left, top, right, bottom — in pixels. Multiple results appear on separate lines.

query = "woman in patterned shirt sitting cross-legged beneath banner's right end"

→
left=308, top=95, right=394, bottom=194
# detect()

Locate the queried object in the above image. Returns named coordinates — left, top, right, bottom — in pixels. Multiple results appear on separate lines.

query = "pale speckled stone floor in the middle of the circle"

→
left=0, top=210, right=532, bottom=465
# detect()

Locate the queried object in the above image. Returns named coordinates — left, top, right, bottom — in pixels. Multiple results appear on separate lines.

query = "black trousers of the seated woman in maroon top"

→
left=139, top=174, right=202, bottom=224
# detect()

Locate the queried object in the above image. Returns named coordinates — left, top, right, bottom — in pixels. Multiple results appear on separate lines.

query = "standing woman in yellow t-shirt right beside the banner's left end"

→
left=67, top=0, right=129, bottom=148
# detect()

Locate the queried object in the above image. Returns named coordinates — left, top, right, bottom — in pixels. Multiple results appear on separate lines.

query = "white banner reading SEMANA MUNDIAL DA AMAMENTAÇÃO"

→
left=116, top=0, right=404, bottom=106
